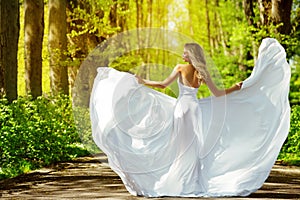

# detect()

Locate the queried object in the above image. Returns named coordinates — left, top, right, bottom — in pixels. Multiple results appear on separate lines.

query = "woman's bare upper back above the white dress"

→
left=177, top=64, right=200, bottom=88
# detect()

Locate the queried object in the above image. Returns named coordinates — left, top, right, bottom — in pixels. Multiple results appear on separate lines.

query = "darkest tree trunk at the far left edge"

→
left=0, top=0, right=20, bottom=102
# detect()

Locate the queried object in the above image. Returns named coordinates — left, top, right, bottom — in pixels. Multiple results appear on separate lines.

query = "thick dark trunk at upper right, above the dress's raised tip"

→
left=272, top=0, right=293, bottom=35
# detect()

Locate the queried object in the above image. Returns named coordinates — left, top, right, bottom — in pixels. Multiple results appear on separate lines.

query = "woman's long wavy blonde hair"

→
left=184, top=43, right=208, bottom=83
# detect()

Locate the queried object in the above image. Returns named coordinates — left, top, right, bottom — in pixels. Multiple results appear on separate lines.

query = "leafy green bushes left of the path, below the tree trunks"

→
left=0, top=96, right=87, bottom=178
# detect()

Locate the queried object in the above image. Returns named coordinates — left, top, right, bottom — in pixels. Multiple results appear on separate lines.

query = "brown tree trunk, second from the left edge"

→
left=24, top=0, right=44, bottom=98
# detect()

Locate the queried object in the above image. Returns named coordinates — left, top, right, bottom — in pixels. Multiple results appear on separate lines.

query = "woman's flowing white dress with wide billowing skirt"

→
left=90, top=38, right=290, bottom=197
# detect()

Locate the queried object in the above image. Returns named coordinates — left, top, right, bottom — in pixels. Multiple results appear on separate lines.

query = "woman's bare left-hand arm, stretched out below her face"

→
left=136, top=66, right=179, bottom=88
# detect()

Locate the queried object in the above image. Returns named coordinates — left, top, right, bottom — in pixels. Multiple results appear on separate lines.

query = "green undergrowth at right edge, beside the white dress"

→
left=278, top=105, right=300, bottom=165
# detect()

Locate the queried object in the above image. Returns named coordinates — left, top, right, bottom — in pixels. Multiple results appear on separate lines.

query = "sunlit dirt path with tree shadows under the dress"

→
left=0, top=155, right=300, bottom=200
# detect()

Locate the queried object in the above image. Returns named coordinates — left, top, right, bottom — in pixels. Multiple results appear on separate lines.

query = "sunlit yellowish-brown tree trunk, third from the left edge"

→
left=48, top=0, right=69, bottom=94
